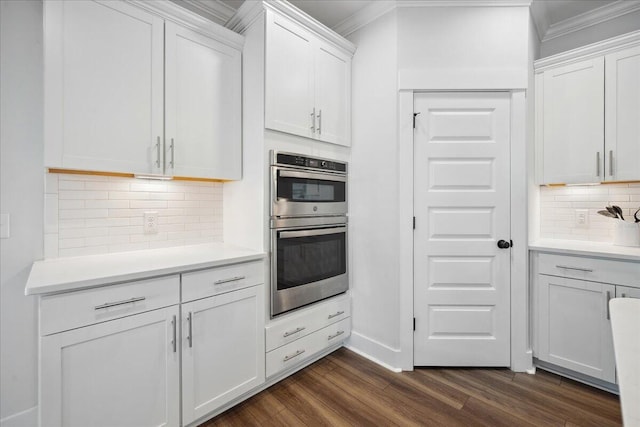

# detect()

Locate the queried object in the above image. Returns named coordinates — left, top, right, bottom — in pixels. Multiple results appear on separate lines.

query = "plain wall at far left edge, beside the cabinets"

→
left=0, top=1, right=44, bottom=426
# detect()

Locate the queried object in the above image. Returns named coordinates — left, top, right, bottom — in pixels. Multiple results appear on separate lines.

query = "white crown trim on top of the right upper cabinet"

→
left=533, top=30, right=640, bottom=73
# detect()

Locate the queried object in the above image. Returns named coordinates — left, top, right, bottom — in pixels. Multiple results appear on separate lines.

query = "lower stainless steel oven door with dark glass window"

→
left=271, top=225, right=349, bottom=316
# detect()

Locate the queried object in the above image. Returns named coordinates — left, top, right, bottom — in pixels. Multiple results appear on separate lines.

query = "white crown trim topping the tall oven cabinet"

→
left=226, top=0, right=356, bottom=55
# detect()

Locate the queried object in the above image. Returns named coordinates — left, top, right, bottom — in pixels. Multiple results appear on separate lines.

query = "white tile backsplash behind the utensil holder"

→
left=540, top=183, right=640, bottom=242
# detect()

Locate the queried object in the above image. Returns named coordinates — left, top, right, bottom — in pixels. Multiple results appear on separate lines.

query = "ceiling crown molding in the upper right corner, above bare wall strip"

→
left=542, top=0, right=640, bottom=42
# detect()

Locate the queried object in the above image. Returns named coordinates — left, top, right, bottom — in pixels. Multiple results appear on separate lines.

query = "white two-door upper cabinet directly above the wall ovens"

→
left=265, top=10, right=352, bottom=146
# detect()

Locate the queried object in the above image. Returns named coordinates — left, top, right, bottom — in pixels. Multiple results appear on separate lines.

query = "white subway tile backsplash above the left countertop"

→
left=44, top=173, right=222, bottom=258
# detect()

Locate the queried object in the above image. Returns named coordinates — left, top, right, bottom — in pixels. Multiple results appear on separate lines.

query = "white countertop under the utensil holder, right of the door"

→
left=529, top=239, right=640, bottom=262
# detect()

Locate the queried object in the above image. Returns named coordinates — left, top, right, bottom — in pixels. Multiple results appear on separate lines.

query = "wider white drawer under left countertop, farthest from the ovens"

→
left=40, top=274, right=180, bottom=336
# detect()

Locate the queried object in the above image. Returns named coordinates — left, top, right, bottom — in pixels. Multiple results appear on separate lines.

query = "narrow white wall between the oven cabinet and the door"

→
left=349, top=11, right=400, bottom=366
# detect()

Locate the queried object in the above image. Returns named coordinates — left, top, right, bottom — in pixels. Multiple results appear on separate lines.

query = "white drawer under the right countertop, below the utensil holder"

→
left=538, top=253, right=640, bottom=287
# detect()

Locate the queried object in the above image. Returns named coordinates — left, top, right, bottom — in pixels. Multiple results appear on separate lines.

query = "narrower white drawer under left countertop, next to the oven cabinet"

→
left=182, top=261, right=264, bottom=302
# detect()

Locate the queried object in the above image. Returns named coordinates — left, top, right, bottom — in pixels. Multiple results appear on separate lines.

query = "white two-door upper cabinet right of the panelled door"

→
left=536, top=32, right=640, bottom=184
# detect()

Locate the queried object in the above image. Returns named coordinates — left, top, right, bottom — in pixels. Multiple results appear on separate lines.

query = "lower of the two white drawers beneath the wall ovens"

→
left=267, top=317, right=351, bottom=377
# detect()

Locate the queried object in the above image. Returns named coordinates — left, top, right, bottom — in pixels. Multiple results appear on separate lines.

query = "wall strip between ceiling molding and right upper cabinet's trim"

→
left=540, top=11, right=640, bottom=58
